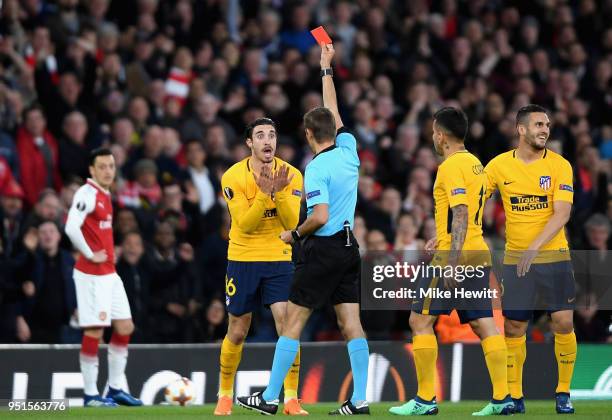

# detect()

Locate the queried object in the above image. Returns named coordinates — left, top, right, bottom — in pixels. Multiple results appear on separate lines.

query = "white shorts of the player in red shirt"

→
left=73, top=270, right=132, bottom=328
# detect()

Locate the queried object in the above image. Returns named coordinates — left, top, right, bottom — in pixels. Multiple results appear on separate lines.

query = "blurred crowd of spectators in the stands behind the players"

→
left=0, top=0, right=612, bottom=343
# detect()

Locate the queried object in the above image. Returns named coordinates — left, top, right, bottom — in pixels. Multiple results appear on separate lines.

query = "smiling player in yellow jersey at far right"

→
left=485, top=105, right=577, bottom=414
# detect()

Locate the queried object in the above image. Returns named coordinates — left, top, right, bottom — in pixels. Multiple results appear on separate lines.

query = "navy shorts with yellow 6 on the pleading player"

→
left=225, top=261, right=293, bottom=316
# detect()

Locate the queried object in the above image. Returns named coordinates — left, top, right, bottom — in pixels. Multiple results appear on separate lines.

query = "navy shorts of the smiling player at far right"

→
left=502, top=261, right=576, bottom=321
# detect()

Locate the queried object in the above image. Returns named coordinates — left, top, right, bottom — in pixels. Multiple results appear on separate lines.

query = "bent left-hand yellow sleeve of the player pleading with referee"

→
left=221, top=168, right=268, bottom=233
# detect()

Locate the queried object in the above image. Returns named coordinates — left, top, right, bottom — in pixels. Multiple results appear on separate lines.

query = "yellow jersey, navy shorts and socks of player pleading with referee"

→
left=219, top=158, right=303, bottom=402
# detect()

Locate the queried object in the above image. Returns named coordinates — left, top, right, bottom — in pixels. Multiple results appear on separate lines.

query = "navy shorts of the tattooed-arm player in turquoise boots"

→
left=412, top=267, right=493, bottom=324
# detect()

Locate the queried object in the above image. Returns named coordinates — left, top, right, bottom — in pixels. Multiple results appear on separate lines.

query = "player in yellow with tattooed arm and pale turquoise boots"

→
left=389, top=107, right=514, bottom=416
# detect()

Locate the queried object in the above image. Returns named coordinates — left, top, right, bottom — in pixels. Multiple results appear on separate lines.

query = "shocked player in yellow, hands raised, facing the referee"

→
left=214, top=118, right=308, bottom=415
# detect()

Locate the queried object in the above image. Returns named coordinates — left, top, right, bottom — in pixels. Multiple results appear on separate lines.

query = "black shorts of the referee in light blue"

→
left=289, top=231, right=361, bottom=309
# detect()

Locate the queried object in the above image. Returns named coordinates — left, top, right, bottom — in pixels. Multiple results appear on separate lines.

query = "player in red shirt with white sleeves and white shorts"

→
left=66, top=148, right=142, bottom=407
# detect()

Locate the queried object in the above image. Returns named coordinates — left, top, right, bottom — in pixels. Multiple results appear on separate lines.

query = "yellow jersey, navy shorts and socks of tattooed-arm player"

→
left=412, top=150, right=508, bottom=404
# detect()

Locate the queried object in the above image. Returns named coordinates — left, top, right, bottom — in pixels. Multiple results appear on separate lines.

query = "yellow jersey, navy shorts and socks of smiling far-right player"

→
left=485, top=149, right=577, bottom=399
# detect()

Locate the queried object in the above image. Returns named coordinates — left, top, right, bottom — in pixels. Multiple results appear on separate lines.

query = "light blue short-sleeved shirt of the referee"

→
left=304, top=127, right=359, bottom=236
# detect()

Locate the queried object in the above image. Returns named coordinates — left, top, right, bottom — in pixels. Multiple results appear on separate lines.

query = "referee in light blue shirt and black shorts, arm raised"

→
left=238, top=44, right=370, bottom=415
